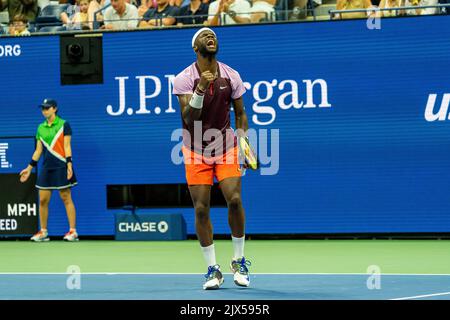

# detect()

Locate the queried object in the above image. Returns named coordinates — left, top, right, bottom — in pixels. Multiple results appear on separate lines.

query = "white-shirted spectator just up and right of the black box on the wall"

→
left=104, top=0, right=139, bottom=30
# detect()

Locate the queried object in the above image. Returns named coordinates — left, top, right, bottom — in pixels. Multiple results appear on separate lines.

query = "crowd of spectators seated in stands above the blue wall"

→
left=0, top=0, right=450, bottom=36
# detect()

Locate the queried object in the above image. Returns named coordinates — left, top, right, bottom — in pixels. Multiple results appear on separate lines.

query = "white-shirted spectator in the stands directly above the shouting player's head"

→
left=208, top=0, right=251, bottom=26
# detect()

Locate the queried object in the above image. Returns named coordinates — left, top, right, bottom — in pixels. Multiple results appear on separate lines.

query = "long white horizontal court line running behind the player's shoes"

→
left=0, top=272, right=450, bottom=276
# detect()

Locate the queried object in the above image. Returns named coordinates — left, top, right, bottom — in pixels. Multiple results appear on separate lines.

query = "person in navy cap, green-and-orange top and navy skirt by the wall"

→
left=20, top=99, right=78, bottom=242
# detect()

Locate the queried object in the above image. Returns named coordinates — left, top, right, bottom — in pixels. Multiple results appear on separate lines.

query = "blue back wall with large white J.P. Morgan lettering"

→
left=0, top=16, right=450, bottom=235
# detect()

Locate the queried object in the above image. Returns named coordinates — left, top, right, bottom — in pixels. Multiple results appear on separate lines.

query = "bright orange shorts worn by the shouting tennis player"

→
left=182, top=146, right=241, bottom=186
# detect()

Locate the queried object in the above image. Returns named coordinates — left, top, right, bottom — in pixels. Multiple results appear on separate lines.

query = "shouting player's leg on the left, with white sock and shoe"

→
left=189, top=185, right=223, bottom=289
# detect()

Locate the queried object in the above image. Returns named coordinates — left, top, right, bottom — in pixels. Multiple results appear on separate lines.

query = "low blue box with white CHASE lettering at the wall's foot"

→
left=115, top=212, right=186, bottom=241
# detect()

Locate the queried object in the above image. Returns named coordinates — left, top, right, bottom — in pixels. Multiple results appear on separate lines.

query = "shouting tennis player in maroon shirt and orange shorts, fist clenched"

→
left=173, top=28, right=250, bottom=289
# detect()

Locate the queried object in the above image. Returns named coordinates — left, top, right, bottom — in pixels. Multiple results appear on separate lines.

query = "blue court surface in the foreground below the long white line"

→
left=0, top=274, right=450, bottom=300
